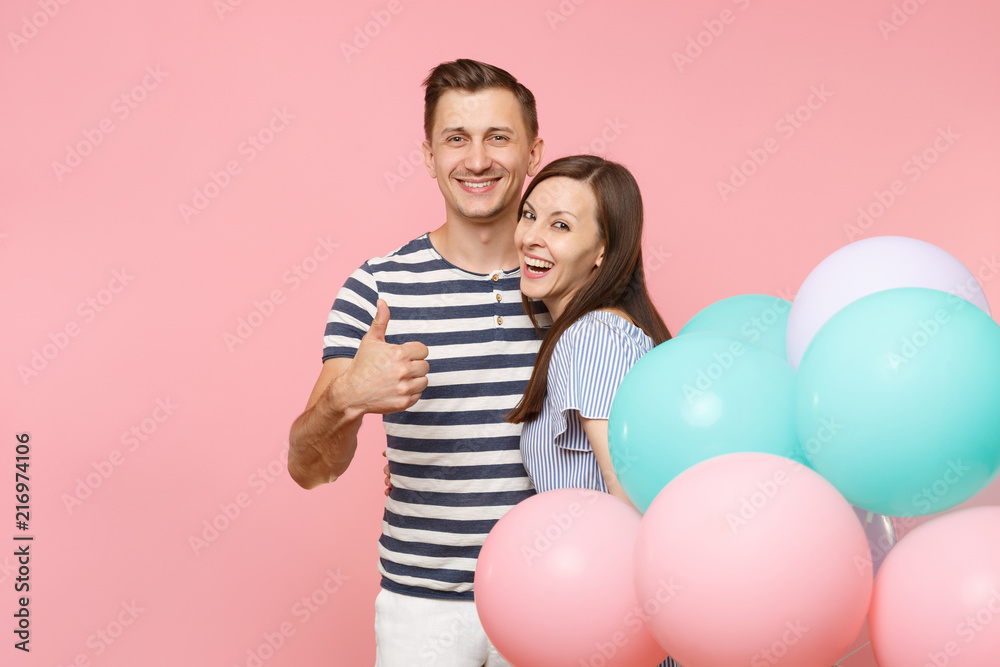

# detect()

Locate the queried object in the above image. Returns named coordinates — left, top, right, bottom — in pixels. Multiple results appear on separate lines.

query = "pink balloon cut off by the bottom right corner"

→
left=869, top=507, right=1000, bottom=667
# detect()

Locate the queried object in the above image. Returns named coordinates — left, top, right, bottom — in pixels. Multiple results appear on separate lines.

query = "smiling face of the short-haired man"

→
left=423, top=88, right=544, bottom=222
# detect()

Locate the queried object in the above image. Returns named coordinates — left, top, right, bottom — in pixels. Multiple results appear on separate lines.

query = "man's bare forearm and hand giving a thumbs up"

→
left=288, top=299, right=429, bottom=489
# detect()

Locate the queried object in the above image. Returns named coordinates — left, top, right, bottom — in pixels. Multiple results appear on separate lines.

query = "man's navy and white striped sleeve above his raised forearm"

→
left=323, top=262, right=379, bottom=361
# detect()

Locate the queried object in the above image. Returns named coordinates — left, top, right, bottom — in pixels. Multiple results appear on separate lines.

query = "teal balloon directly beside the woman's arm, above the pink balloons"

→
left=608, top=332, right=805, bottom=512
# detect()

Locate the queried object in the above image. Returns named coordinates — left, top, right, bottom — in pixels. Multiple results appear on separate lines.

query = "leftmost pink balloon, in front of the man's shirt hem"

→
left=475, top=489, right=672, bottom=667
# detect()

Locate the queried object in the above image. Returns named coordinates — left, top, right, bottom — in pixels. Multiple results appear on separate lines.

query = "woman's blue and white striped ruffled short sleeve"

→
left=546, top=320, right=643, bottom=450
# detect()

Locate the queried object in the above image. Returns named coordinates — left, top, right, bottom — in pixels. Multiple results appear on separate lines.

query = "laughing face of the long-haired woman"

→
left=514, top=176, right=604, bottom=319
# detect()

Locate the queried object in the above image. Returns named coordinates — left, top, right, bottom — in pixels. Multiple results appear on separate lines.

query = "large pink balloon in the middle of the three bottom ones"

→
left=635, top=452, right=872, bottom=667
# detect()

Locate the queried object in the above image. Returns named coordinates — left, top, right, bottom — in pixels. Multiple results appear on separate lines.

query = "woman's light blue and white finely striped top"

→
left=521, top=310, right=653, bottom=493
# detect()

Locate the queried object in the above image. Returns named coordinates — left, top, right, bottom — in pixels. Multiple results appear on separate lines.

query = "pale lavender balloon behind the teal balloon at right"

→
left=787, top=236, right=990, bottom=368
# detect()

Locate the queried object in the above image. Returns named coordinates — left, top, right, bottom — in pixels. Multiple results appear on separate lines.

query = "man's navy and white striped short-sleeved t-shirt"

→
left=323, top=234, right=551, bottom=600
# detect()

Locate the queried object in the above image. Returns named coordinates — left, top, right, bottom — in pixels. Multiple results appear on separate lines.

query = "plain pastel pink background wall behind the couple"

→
left=0, top=0, right=1000, bottom=667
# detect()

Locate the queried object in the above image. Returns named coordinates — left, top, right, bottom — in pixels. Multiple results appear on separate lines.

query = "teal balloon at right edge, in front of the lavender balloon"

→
left=795, top=287, right=1000, bottom=517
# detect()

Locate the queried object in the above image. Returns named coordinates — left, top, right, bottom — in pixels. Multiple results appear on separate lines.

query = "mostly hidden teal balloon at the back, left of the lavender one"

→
left=677, top=294, right=792, bottom=359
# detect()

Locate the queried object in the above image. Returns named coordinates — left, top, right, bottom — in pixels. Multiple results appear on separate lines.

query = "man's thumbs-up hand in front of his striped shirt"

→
left=340, top=299, right=430, bottom=414
